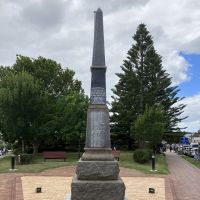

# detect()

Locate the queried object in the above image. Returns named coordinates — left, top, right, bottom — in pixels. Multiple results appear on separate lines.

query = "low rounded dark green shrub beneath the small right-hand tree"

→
left=133, top=149, right=151, bottom=164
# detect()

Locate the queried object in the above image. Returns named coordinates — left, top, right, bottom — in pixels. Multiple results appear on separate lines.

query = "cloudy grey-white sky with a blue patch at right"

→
left=0, top=0, right=200, bottom=132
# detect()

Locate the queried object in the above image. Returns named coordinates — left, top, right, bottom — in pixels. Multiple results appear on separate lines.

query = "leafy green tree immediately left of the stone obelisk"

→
left=50, top=92, right=89, bottom=147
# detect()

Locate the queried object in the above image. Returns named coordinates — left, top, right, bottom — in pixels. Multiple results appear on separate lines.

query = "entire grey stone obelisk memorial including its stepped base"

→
left=71, top=9, right=125, bottom=200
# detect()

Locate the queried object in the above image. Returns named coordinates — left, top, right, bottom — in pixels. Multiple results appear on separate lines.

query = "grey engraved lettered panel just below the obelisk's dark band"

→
left=90, top=87, right=106, bottom=104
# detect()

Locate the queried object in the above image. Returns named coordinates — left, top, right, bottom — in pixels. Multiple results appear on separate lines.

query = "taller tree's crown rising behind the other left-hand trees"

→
left=13, top=55, right=83, bottom=100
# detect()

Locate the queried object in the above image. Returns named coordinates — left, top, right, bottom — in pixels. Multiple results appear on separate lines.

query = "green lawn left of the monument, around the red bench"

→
left=0, top=152, right=78, bottom=173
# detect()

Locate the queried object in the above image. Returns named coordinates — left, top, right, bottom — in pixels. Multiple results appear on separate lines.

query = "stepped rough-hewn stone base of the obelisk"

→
left=70, top=148, right=125, bottom=200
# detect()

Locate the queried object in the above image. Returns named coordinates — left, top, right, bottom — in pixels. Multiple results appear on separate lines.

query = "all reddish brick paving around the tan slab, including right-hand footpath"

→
left=0, top=152, right=200, bottom=200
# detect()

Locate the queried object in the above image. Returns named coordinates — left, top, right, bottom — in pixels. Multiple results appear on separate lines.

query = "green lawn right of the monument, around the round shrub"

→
left=120, top=151, right=169, bottom=174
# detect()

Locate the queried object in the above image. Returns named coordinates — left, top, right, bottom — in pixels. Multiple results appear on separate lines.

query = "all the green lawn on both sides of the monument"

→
left=0, top=151, right=168, bottom=174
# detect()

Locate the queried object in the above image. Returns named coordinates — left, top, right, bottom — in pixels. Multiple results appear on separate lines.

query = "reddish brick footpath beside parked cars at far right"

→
left=166, top=152, right=200, bottom=200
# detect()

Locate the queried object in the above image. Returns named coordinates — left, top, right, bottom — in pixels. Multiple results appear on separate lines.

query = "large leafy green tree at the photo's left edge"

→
left=0, top=72, right=47, bottom=154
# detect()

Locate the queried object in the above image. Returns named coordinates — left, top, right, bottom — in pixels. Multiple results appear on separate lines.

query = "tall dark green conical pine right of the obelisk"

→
left=111, top=24, right=185, bottom=148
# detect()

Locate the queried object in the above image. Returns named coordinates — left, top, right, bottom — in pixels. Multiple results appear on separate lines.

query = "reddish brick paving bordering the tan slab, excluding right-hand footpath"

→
left=0, top=166, right=173, bottom=200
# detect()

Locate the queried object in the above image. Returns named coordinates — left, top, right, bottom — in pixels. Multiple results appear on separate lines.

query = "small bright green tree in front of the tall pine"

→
left=134, top=106, right=165, bottom=150
